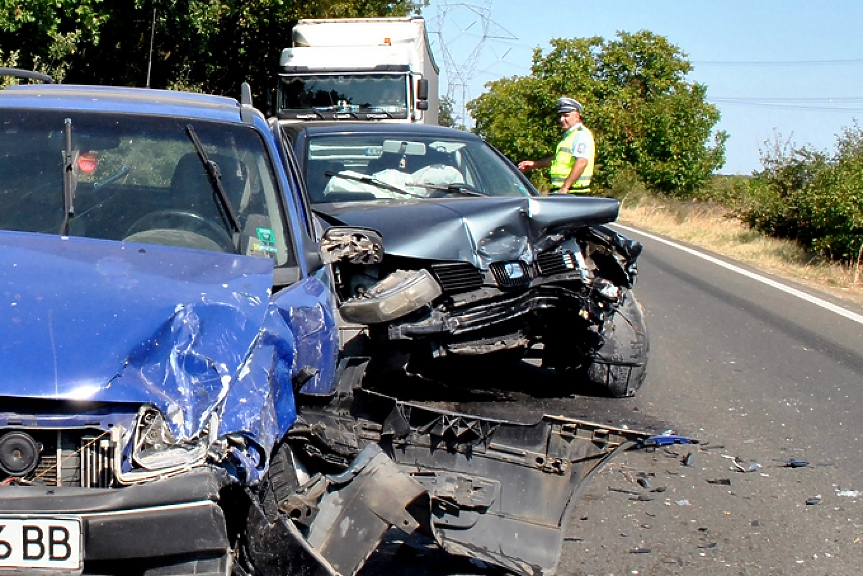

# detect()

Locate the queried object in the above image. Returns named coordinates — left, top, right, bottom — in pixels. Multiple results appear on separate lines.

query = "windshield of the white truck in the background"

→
left=279, top=74, right=408, bottom=118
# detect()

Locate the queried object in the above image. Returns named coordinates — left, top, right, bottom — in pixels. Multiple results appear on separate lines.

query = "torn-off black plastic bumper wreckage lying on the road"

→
left=243, top=380, right=646, bottom=576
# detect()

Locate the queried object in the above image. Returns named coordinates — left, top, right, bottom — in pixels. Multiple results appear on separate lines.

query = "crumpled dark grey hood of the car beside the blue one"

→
left=314, top=195, right=620, bottom=269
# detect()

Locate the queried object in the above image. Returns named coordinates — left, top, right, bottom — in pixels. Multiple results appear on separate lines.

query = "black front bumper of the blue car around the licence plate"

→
left=0, top=469, right=229, bottom=574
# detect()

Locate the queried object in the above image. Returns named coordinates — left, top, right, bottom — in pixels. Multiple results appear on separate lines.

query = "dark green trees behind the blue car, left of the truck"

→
left=0, top=0, right=422, bottom=108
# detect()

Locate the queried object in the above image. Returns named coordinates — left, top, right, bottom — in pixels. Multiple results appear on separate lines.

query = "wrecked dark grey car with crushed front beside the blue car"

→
left=282, top=122, right=649, bottom=396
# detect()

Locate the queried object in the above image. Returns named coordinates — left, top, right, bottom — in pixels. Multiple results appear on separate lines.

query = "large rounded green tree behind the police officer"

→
left=468, top=31, right=728, bottom=198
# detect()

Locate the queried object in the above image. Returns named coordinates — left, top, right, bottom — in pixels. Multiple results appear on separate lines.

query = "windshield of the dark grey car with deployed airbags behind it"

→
left=305, top=132, right=534, bottom=204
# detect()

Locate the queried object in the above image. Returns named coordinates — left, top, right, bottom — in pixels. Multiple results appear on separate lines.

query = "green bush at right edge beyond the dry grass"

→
left=738, top=123, right=863, bottom=262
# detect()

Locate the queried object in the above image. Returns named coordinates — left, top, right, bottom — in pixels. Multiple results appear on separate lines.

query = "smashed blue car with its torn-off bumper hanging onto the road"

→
left=0, top=76, right=642, bottom=576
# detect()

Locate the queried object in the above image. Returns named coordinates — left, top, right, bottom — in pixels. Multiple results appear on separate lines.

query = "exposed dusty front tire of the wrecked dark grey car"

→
left=586, top=292, right=650, bottom=398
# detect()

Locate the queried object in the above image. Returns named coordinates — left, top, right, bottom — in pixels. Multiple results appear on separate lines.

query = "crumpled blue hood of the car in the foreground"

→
left=0, top=232, right=334, bottom=445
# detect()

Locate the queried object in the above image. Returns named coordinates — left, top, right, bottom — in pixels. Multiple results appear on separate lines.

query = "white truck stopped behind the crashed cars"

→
left=275, top=17, right=440, bottom=124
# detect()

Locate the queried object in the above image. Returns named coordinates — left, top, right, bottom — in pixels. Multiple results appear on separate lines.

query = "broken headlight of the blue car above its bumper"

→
left=114, top=407, right=218, bottom=484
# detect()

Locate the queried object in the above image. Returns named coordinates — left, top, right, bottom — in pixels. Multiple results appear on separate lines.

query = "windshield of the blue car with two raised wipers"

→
left=0, top=110, right=292, bottom=265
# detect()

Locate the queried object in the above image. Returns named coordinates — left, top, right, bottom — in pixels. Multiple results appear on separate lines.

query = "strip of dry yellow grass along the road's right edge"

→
left=618, top=195, right=863, bottom=304
